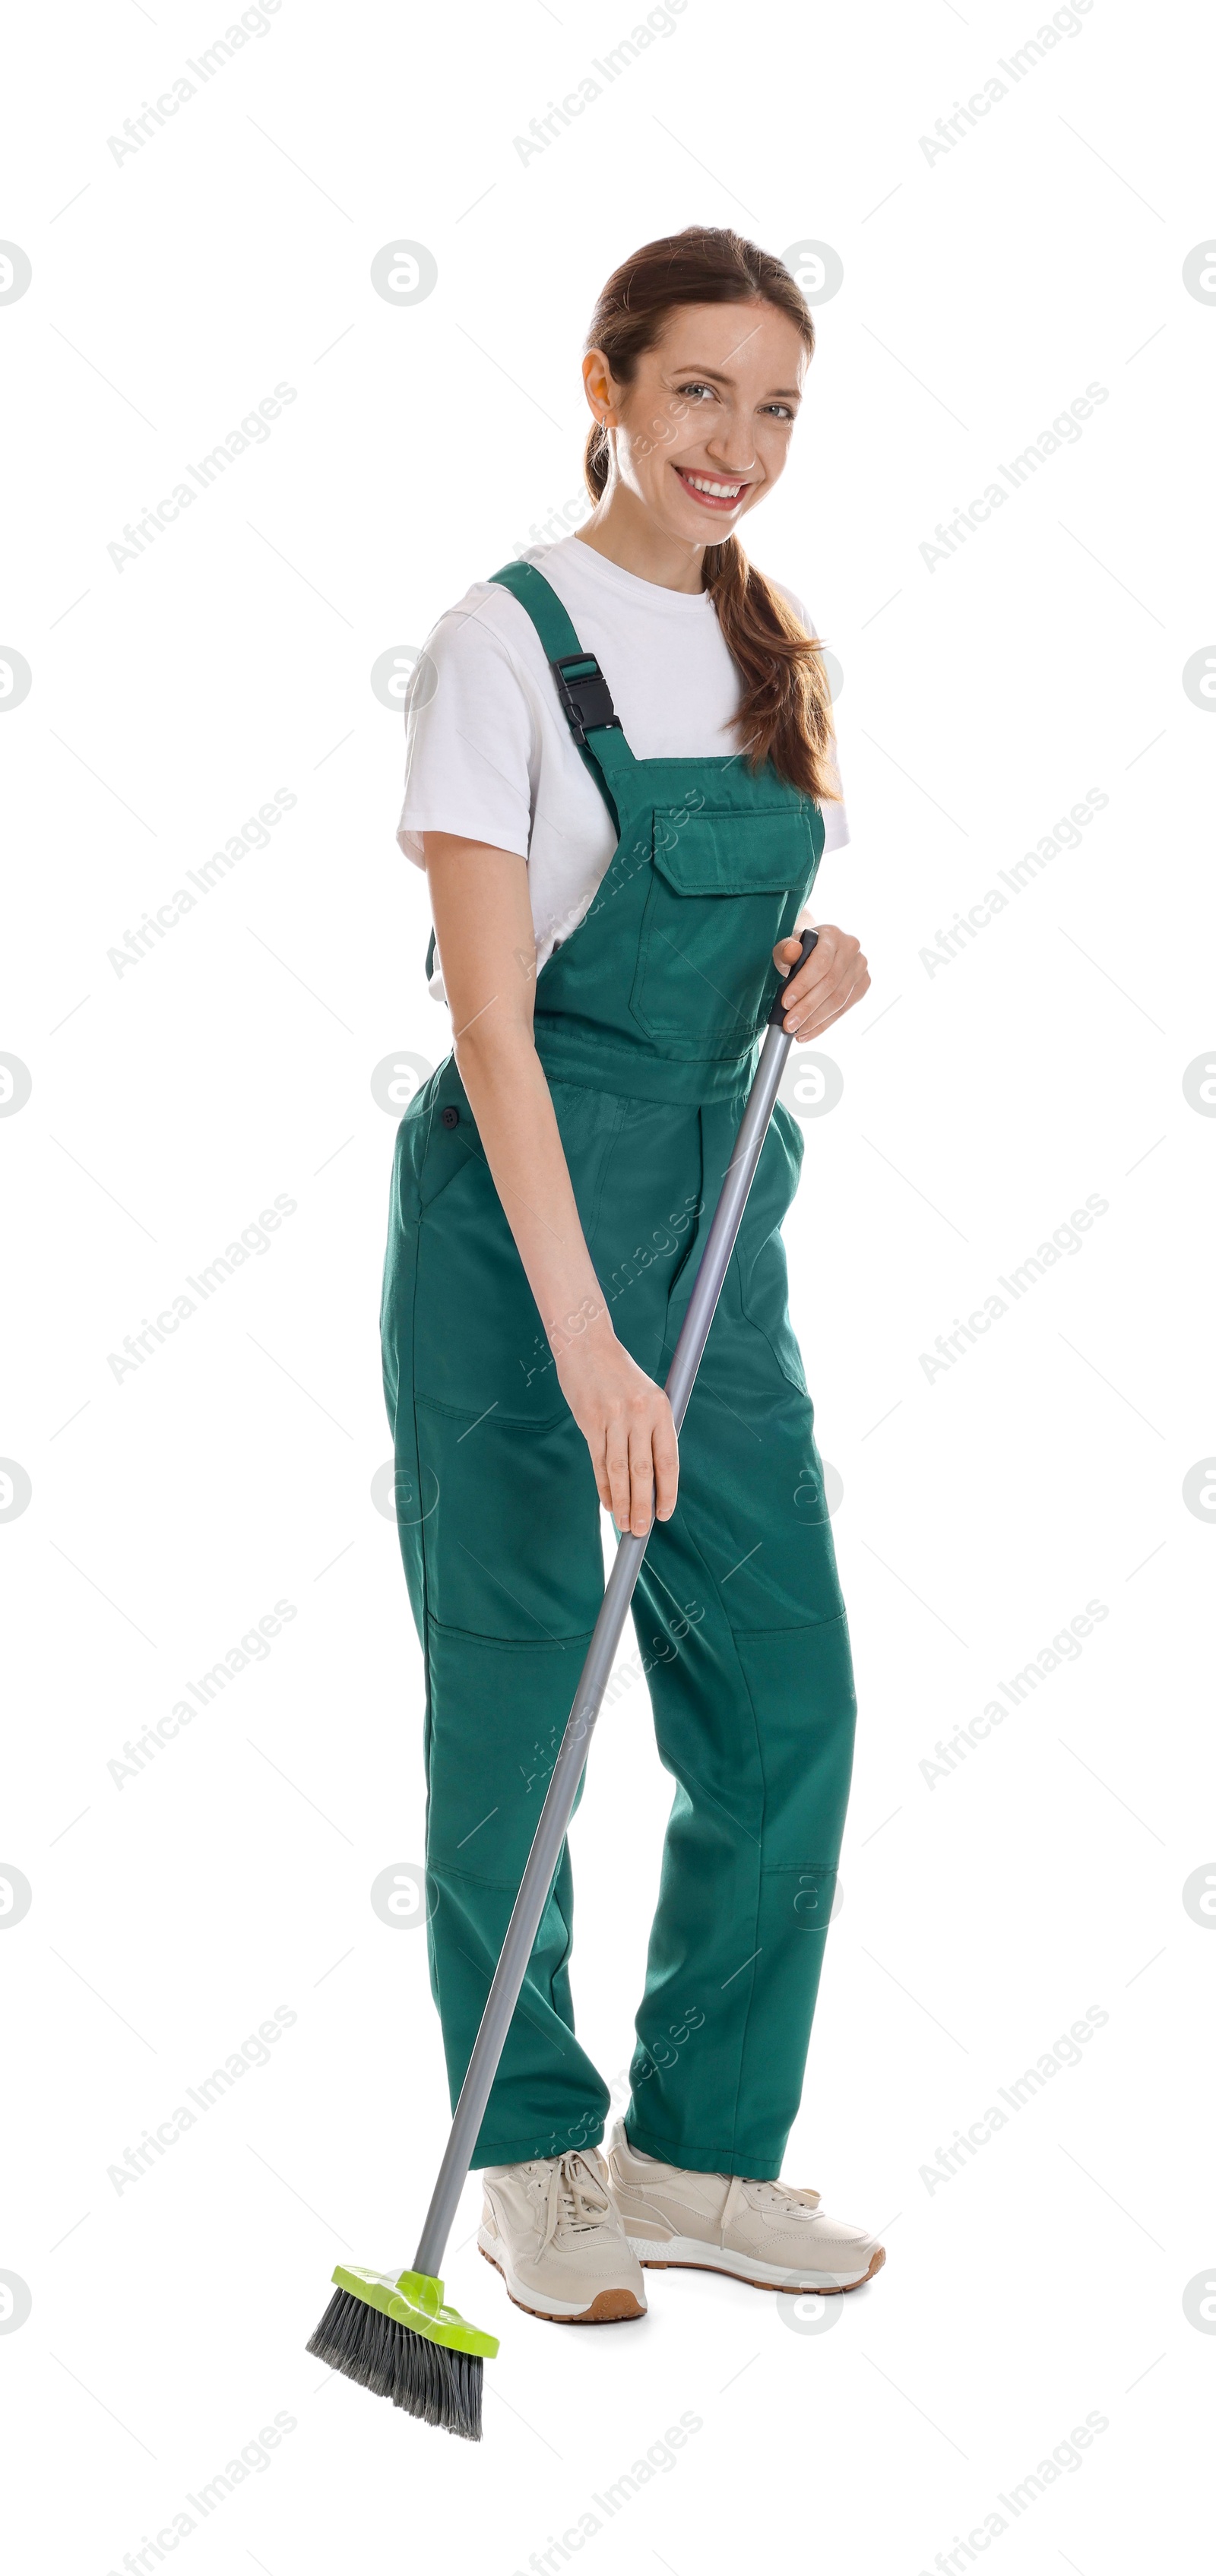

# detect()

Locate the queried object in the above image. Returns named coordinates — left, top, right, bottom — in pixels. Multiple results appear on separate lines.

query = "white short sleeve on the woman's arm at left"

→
left=397, top=603, right=538, bottom=868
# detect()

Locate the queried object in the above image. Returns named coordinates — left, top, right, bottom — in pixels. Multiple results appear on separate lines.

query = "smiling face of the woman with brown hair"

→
left=582, top=302, right=809, bottom=549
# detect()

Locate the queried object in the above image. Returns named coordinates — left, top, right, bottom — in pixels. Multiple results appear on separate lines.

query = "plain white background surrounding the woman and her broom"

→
left=0, top=0, right=1216, bottom=2576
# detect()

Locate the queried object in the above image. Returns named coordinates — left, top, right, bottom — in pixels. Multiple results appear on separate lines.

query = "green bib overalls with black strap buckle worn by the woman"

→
left=382, top=564, right=855, bottom=2179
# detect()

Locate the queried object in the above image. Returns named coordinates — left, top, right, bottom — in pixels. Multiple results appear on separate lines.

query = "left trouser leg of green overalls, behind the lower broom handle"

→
left=384, top=1062, right=641, bottom=2164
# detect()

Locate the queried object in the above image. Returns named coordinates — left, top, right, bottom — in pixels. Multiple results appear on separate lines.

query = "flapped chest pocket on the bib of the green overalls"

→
left=629, top=799, right=825, bottom=1062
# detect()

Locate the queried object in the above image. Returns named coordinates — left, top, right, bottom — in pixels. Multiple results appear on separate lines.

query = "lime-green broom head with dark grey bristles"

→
left=306, top=2261, right=497, bottom=2442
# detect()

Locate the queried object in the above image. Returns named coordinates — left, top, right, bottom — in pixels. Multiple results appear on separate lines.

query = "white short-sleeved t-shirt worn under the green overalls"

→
left=397, top=536, right=847, bottom=1002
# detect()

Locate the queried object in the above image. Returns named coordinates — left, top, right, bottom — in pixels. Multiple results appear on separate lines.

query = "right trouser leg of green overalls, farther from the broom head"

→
left=590, top=1105, right=855, bottom=2179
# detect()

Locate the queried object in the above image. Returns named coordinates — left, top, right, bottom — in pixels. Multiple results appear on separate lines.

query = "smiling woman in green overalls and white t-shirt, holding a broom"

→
left=384, top=226, right=884, bottom=2324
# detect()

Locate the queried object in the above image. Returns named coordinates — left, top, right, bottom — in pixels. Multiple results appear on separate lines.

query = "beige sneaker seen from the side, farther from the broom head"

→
left=608, top=2120, right=886, bottom=2290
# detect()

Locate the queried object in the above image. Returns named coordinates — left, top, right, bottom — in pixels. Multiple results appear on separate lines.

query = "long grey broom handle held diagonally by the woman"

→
left=412, top=930, right=817, bottom=2280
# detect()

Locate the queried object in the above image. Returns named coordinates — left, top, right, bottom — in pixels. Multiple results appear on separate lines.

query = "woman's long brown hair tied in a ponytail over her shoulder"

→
left=582, top=224, right=840, bottom=804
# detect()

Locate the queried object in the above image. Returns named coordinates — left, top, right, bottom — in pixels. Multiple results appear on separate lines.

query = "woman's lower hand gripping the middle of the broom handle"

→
left=556, top=1312, right=680, bottom=1538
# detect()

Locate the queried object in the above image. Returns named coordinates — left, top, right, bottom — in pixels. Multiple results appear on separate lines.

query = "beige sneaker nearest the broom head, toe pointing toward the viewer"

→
left=477, top=2146, right=647, bottom=2326
